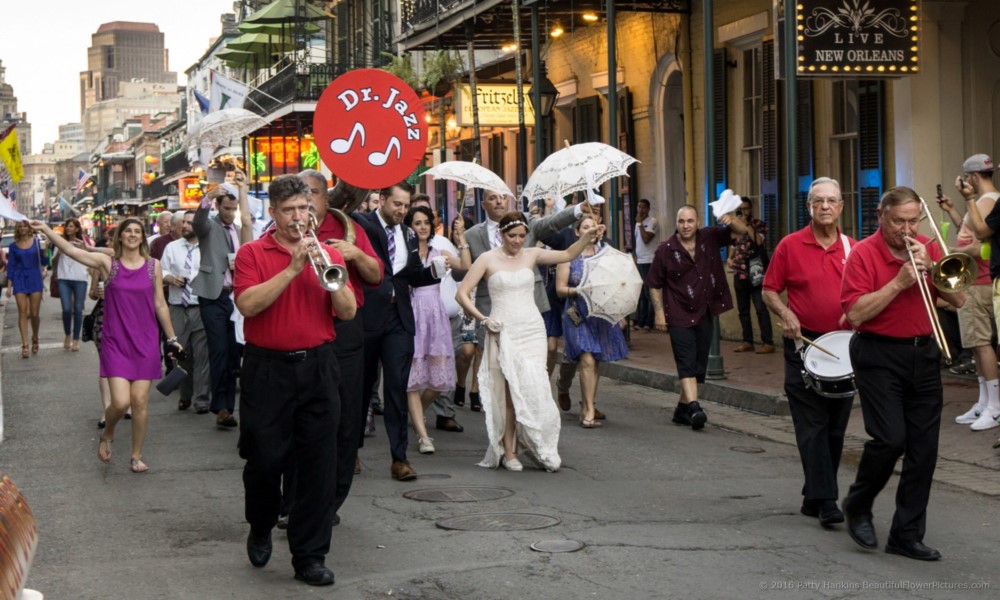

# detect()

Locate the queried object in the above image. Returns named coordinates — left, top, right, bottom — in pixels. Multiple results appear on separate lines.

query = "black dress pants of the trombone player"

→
left=844, top=334, right=942, bottom=542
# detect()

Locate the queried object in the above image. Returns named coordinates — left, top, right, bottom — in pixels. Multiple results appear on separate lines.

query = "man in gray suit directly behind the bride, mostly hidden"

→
left=455, top=190, right=590, bottom=412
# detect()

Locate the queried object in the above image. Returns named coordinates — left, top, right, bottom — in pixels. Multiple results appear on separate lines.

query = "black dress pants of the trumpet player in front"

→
left=239, top=343, right=340, bottom=569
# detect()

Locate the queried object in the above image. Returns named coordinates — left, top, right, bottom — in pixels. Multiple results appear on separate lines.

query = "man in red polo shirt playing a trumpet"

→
left=234, top=175, right=357, bottom=585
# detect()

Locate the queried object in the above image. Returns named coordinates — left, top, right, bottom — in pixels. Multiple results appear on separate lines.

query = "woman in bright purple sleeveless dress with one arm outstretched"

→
left=31, top=218, right=183, bottom=473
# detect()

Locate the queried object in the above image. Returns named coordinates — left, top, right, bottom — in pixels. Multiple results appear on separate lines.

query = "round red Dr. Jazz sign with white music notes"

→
left=313, top=69, right=427, bottom=189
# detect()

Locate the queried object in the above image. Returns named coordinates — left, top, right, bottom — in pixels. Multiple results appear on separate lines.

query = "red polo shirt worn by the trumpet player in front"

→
left=233, top=231, right=344, bottom=350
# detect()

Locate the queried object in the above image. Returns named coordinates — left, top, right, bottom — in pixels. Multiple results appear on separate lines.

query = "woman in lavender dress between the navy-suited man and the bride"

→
left=404, top=206, right=469, bottom=454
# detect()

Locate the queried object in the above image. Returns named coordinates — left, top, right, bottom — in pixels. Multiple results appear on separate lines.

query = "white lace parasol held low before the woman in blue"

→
left=577, top=246, right=642, bottom=323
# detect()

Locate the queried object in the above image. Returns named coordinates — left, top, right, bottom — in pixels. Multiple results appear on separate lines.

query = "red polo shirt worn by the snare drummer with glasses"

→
left=764, top=225, right=858, bottom=333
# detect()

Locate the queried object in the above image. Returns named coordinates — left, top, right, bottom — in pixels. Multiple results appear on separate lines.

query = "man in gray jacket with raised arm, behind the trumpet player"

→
left=191, top=171, right=253, bottom=429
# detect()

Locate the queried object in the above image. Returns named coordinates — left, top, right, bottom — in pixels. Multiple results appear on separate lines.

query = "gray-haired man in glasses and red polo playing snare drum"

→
left=764, top=177, right=857, bottom=527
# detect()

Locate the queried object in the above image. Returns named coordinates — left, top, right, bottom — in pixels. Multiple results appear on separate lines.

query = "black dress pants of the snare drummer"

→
left=785, top=329, right=854, bottom=504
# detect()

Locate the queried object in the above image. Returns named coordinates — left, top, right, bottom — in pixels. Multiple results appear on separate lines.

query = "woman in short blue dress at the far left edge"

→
left=7, top=221, right=49, bottom=358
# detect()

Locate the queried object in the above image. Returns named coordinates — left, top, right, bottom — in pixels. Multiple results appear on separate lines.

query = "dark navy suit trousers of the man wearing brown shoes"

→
left=362, top=305, right=413, bottom=468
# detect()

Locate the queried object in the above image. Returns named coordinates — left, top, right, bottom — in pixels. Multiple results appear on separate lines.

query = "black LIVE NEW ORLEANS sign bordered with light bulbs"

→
left=786, top=0, right=920, bottom=77
